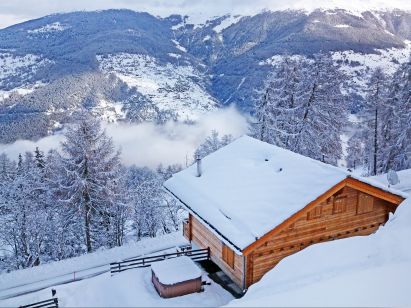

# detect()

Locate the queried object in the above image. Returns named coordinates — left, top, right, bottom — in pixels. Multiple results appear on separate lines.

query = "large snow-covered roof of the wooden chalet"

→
left=164, top=136, right=401, bottom=251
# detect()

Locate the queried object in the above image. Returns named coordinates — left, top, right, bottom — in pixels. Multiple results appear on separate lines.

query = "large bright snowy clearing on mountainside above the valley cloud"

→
left=97, top=53, right=217, bottom=120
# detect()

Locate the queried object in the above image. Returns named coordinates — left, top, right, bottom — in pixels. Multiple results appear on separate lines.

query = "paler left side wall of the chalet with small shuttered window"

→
left=189, top=214, right=244, bottom=288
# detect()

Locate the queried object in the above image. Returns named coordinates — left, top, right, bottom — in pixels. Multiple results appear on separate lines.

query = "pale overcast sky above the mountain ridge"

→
left=0, top=0, right=411, bottom=28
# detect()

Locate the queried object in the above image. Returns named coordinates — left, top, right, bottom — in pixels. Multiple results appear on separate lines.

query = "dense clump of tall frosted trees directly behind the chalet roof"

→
left=256, top=54, right=346, bottom=164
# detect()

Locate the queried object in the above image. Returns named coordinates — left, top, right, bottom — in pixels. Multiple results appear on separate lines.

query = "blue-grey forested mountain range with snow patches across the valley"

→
left=0, top=9, right=411, bottom=142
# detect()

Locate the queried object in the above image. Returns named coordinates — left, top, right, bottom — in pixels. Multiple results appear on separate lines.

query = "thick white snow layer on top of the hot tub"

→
left=151, top=256, right=201, bottom=285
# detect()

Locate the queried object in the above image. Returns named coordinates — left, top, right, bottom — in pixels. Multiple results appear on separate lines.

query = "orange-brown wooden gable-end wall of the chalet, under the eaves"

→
left=246, top=186, right=396, bottom=287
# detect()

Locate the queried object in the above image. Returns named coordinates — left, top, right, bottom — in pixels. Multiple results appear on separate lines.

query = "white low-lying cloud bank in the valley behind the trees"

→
left=0, top=107, right=249, bottom=168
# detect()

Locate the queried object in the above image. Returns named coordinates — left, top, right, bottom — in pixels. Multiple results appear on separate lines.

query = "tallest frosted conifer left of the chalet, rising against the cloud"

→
left=60, top=116, right=125, bottom=252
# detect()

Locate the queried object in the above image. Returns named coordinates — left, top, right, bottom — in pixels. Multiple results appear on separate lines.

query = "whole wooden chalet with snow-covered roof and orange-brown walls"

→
left=165, top=136, right=407, bottom=290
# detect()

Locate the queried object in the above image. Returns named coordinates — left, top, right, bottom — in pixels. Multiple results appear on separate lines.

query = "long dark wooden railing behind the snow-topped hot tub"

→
left=110, top=248, right=210, bottom=274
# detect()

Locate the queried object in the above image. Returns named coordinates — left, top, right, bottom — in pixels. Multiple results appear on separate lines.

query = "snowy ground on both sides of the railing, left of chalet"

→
left=0, top=233, right=233, bottom=307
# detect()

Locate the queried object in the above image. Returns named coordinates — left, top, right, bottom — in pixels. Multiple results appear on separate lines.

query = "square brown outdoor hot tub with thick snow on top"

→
left=151, top=256, right=201, bottom=298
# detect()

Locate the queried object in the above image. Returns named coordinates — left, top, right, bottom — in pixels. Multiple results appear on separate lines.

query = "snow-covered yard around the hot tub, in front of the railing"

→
left=0, top=267, right=233, bottom=307
